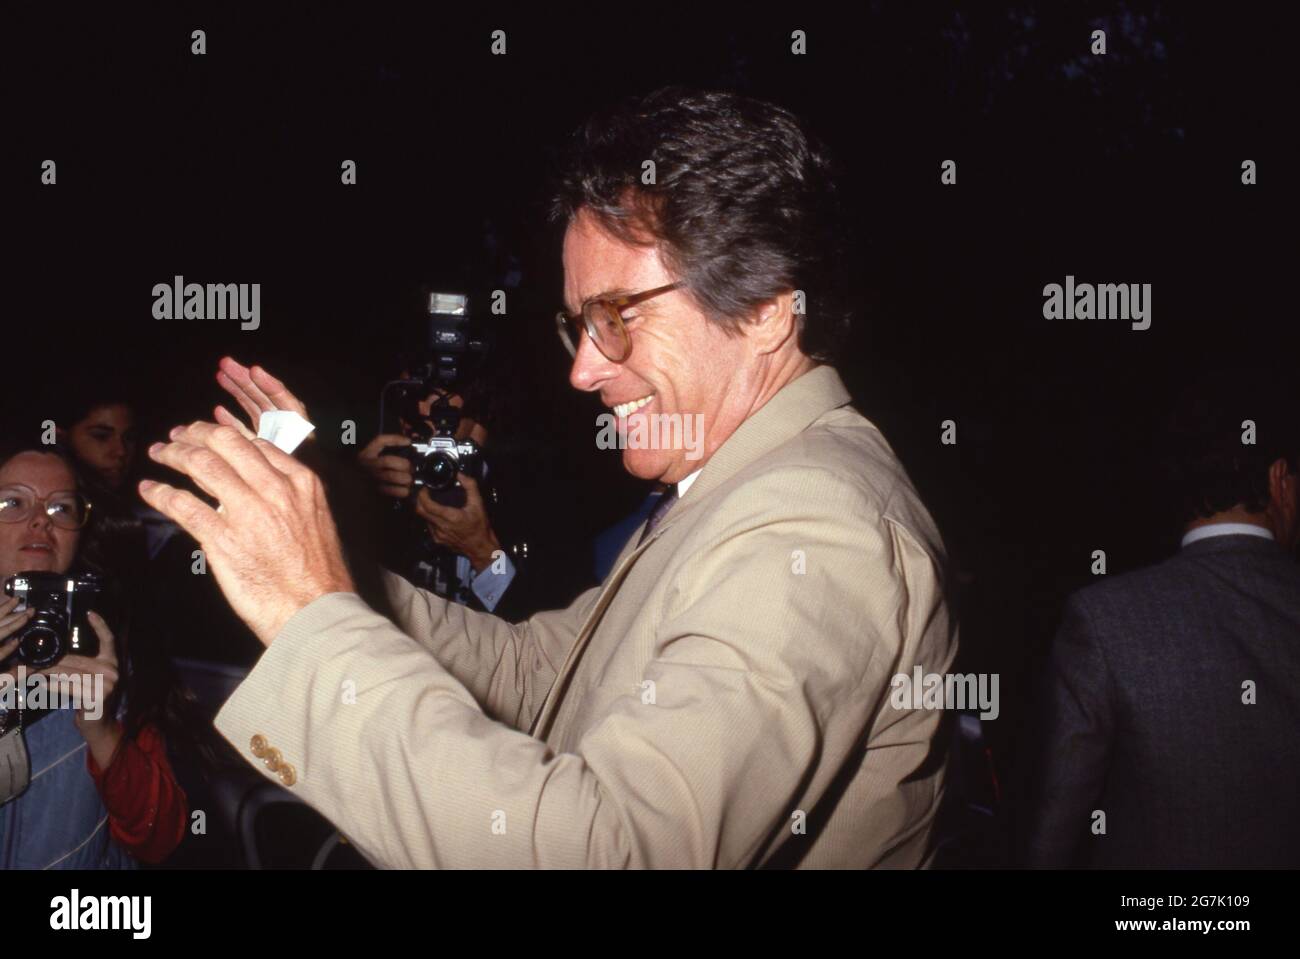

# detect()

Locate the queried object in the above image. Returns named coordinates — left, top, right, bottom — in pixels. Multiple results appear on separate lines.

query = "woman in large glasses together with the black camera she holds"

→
left=0, top=446, right=187, bottom=869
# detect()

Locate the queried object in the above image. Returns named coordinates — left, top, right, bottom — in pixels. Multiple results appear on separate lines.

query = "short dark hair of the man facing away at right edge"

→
left=1161, top=369, right=1300, bottom=522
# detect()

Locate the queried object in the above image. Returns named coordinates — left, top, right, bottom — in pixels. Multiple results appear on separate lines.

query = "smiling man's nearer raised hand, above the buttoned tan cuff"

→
left=139, top=422, right=356, bottom=645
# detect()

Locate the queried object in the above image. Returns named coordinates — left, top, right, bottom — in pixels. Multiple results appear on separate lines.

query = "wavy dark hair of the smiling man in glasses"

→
left=551, top=87, right=850, bottom=361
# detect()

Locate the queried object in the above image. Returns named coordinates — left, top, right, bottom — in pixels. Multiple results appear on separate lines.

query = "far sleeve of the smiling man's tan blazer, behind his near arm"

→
left=384, top=563, right=598, bottom=729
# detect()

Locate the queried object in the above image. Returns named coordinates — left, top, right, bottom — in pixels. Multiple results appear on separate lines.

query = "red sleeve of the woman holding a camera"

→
left=86, top=726, right=189, bottom=863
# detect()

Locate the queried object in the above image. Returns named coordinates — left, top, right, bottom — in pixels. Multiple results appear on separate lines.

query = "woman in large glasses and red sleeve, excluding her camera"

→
left=0, top=447, right=187, bottom=869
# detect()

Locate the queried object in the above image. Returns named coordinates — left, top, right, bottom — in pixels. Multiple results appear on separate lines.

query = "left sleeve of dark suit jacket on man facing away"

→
left=1026, top=595, right=1114, bottom=868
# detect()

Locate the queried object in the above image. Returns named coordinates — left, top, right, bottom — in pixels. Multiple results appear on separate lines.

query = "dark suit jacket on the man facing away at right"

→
left=1026, top=535, right=1300, bottom=867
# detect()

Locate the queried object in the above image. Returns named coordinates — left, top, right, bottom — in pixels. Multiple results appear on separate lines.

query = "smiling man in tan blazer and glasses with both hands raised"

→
left=140, top=90, right=956, bottom=868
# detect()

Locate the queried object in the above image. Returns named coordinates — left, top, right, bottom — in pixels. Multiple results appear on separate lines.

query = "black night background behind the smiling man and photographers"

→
left=0, top=3, right=1296, bottom=857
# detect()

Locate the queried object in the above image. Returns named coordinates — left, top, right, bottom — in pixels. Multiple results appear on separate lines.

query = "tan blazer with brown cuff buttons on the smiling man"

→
left=217, top=366, right=957, bottom=868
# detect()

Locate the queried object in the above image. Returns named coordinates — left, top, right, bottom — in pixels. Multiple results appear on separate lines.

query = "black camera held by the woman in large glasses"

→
left=0, top=572, right=104, bottom=669
